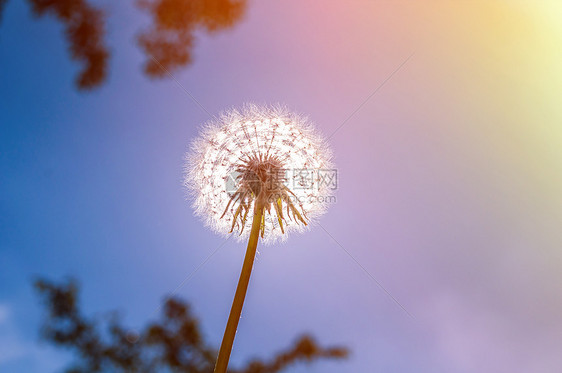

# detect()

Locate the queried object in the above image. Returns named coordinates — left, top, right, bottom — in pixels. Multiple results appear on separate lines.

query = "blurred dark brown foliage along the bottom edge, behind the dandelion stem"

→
left=35, top=279, right=348, bottom=373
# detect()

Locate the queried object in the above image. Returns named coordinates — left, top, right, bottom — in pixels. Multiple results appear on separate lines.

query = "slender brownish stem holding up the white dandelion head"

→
left=215, top=202, right=263, bottom=373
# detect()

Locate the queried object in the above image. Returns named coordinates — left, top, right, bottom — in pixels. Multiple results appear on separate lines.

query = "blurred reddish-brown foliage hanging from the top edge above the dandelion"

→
left=0, top=0, right=246, bottom=90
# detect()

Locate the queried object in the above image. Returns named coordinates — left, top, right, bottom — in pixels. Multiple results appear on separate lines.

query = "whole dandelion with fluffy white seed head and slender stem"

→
left=185, top=104, right=332, bottom=373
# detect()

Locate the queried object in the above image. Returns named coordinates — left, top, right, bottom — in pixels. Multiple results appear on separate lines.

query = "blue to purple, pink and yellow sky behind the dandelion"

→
left=0, top=0, right=562, bottom=373
